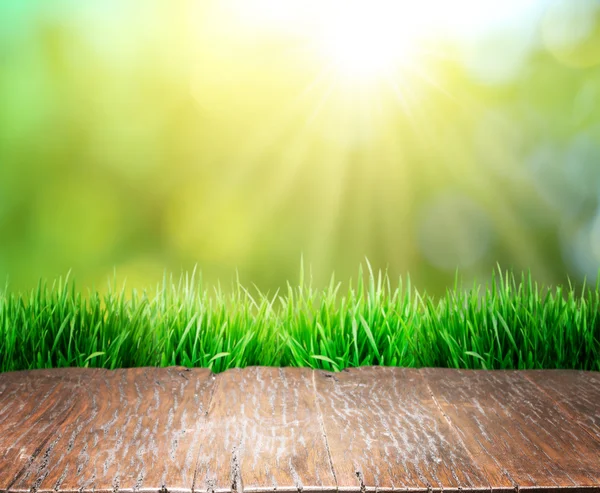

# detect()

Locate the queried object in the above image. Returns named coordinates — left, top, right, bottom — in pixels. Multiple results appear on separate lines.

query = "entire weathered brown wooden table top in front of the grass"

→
left=0, top=367, right=600, bottom=493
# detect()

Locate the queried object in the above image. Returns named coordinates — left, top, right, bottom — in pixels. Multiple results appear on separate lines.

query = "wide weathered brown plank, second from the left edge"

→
left=11, top=368, right=214, bottom=492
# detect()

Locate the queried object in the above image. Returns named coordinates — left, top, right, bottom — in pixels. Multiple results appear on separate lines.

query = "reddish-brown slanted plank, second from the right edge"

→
left=425, top=369, right=600, bottom=491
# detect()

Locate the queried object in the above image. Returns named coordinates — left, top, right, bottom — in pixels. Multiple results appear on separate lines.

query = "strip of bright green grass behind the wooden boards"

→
left=0, top=268, right=600, bottom=371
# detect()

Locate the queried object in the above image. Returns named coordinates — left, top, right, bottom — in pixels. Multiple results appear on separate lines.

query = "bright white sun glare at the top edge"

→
left=230, top=0, right=432, bottom=82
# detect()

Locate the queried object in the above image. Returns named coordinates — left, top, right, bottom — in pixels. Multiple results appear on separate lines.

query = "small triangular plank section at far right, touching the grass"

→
left=521, top=370, right=600, bottom=442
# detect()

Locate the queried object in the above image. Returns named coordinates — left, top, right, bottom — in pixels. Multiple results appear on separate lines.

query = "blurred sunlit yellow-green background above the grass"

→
left=0, top=0, right=600, bottom=293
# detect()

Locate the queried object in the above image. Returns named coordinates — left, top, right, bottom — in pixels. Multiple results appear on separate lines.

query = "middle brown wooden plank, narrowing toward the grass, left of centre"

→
left=195, top=368, right=336, bottom=493
